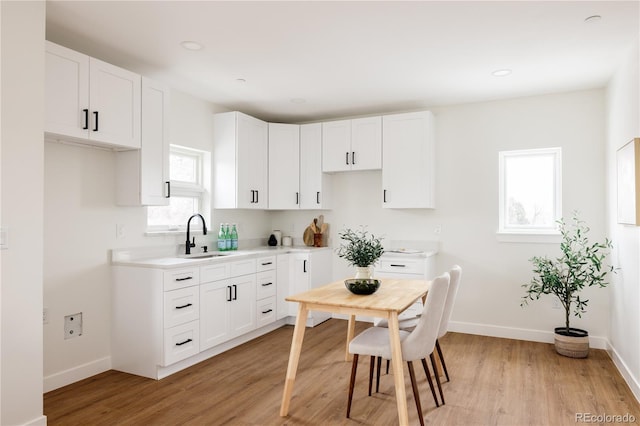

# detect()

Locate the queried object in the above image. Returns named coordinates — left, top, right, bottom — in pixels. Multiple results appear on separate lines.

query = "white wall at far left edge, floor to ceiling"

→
left=0, top=1, right=46, bottom=425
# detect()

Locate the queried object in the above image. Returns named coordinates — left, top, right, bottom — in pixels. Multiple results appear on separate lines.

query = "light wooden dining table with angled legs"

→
left=280, top=278, right=430, bottom=425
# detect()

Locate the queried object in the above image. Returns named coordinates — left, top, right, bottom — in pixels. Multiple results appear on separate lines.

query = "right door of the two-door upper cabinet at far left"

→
left=89, top=58, right=141, bottom=149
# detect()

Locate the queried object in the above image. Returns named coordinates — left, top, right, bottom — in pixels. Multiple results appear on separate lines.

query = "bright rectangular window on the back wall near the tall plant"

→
left=498, top=148, right=562, bottom=241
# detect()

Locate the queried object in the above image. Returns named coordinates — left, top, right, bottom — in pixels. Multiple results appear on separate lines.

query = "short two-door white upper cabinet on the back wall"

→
left=322, top=117, right=382, bottom=172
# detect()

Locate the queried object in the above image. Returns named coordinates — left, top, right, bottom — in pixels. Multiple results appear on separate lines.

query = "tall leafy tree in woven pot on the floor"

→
left=520, top=213, right=614, bottom=358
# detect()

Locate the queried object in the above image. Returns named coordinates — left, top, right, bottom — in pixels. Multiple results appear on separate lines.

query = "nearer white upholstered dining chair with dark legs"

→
left=347, top=272, right=450, bottom=425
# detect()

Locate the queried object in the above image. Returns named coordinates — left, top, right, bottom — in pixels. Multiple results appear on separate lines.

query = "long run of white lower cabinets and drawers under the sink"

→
left=111, top=250, right=332, bottom=379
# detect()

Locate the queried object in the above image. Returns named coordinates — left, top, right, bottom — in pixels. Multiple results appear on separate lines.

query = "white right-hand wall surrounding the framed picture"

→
left=607, top=36, right=640, bottom=399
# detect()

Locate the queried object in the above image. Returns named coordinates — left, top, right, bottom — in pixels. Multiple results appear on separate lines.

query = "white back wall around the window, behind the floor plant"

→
left=273, top=90, right=609, bottom=347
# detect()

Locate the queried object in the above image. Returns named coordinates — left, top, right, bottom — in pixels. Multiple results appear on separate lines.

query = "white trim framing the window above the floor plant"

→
left=497, top=147, right=562, bottom=243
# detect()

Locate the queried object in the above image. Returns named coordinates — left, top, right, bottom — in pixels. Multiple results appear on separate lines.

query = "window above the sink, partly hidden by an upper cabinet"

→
left=147, top=145, right=211, bottom=232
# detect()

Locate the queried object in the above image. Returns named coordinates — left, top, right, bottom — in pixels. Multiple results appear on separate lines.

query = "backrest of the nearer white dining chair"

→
left=402, top=272, right=449, bottom=361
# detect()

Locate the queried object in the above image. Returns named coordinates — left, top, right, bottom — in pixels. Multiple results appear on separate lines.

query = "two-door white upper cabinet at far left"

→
left=45, top=42, right=141, bottom=149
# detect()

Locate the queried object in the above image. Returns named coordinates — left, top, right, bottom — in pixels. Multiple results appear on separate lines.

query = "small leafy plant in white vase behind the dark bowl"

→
left=336, top=228, right=384, bottom=278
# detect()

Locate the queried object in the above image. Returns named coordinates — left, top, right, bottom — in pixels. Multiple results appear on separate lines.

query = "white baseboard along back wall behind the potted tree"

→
left=449, top=321, right=608, bottom=349
